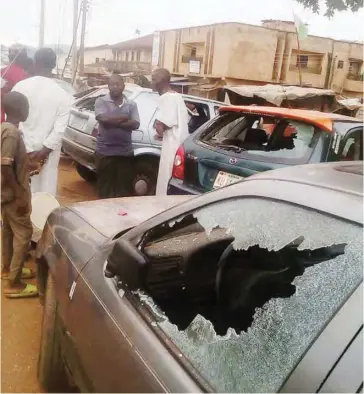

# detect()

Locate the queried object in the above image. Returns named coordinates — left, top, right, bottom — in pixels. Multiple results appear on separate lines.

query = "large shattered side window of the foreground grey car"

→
left=138, top=198, right=363, bottom=392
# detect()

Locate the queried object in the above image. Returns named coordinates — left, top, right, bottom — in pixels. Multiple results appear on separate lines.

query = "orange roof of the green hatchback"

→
left=220, top=105, right=361, bottom=132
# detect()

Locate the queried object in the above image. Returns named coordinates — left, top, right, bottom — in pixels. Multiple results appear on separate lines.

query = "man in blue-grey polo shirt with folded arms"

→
left=95, top=74, right=140, bottom=198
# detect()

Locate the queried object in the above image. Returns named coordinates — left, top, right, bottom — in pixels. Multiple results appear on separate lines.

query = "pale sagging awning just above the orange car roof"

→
left=224, top=85, right=335, bottom=107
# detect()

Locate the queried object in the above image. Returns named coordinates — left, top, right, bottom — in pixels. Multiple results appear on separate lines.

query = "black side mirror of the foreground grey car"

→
left=105, top=239, right=148, bottom=290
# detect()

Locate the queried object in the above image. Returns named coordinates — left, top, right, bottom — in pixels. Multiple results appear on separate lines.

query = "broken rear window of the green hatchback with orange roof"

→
left=201, top=113, right=318, bottom=163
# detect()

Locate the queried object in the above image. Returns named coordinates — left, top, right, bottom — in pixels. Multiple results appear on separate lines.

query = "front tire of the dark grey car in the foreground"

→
left=38, top=274, right=72, bottom=393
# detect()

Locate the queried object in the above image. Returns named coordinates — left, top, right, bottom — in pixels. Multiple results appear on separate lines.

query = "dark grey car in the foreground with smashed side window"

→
left=37, top=162, right=363, bottom=393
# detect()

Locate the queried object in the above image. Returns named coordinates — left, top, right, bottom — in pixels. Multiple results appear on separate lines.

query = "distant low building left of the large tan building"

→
left=108, top=34, right=153, bottom=73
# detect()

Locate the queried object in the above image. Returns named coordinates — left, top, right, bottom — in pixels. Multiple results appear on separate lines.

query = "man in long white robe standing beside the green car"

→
left=152, top=68, right=189, bottom=195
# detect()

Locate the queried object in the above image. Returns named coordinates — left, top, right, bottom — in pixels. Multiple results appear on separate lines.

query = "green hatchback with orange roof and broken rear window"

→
left=168, top=106, right=363, bottom=195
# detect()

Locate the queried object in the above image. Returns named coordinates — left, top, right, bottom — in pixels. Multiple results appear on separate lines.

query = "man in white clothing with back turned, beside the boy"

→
left=13, top=48, right=73, bottom=197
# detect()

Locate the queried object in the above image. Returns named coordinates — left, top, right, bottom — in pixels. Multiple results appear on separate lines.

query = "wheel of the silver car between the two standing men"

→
left=133, top=158, right=159, bottom=196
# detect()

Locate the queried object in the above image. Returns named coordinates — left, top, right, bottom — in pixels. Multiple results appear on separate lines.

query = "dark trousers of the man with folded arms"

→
left=96, top=154, right=134, bottom=198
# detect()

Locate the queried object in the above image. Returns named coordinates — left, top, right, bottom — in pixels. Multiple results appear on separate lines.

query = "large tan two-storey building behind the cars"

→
left=153, top=20, right=363, bottom=97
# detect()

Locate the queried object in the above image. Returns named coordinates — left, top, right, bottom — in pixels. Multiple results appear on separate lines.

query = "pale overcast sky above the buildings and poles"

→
left=0, top=0, right=364, bottom=46
